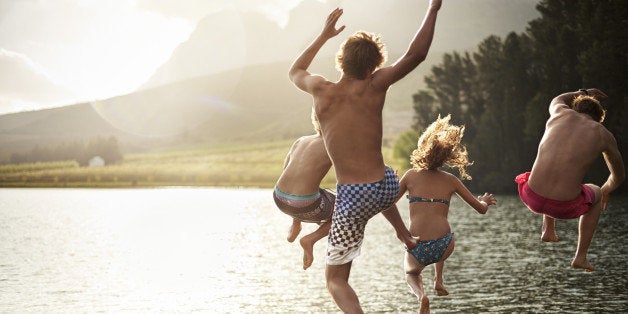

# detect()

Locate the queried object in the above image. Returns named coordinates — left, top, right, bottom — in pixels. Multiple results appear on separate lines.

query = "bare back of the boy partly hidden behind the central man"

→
left=277, top=135, right=331, bottom=195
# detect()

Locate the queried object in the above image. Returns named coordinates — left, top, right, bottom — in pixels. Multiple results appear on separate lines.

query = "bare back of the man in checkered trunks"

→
left=313, top=79, right=386, bottom=184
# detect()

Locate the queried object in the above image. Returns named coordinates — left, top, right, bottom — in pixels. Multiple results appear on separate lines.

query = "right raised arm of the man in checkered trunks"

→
left=373, top=0, right=442, bottom=89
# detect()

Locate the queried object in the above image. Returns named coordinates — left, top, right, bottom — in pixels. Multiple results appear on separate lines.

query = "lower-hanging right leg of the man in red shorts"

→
left=571, top=184, right=602, bottom=272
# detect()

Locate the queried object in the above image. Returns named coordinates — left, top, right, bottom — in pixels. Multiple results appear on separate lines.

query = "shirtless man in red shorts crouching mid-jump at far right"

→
left=515, top=88, right=625, bottom=271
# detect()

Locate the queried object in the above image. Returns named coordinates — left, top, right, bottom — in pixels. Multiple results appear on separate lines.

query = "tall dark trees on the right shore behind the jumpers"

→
left=395, top=0, right=628, bottom=193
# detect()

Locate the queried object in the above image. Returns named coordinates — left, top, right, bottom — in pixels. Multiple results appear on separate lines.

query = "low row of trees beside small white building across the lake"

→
left=8, top=136, right=123, bottom=166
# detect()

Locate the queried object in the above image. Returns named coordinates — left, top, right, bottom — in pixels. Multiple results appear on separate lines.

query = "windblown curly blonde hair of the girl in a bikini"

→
left=410, top=114, right=473, bottom=180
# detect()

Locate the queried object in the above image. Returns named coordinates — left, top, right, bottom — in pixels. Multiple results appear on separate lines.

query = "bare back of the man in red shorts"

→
left=528, top=107, right=612, bottom=200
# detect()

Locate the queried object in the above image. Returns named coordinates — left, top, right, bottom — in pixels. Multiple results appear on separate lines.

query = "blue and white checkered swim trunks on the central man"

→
left=326, top=166, right=399, bottom=265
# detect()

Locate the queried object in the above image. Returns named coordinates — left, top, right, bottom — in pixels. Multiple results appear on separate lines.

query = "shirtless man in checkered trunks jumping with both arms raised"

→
left=289, top=0, right=441, bottom=313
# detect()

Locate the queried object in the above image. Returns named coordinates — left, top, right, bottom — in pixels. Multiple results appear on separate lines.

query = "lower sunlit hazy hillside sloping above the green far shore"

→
left=0, top=59, right=426, bottom=161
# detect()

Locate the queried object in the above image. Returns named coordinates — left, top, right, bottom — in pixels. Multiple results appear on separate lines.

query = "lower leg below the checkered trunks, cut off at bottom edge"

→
left=325, top=262, right=364, bottom=313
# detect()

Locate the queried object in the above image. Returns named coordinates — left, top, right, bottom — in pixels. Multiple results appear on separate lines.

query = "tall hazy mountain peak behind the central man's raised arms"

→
left=142, top=0, right=539, bottom=88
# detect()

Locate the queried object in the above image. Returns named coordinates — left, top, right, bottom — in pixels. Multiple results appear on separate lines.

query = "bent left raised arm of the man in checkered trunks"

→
left=288, top=8, right=345, bottom=94
